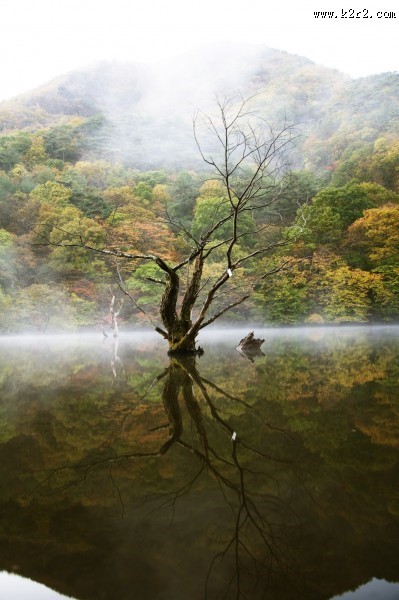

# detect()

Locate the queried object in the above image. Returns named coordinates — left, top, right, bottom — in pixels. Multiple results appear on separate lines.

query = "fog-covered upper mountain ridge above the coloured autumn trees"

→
left=0, top=44, right=399, bottom=171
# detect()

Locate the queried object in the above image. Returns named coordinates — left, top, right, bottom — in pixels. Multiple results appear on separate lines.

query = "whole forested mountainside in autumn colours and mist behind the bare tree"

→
left=0, top=45, right=399, bottom=333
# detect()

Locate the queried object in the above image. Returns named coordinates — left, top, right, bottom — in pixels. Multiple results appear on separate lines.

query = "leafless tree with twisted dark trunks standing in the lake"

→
left=36, top=98, right=293, bottom=354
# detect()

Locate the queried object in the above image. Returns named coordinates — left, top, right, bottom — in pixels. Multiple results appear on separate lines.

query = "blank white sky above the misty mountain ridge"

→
left=0, top=0, right=399, bottom=100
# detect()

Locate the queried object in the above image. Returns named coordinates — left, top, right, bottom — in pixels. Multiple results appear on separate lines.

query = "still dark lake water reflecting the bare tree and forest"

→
left=0, top=327, right=399, bottom=600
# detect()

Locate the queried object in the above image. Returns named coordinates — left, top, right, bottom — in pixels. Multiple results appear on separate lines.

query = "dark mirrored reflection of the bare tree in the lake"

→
left=39, top=357, right=298, bottom=598
